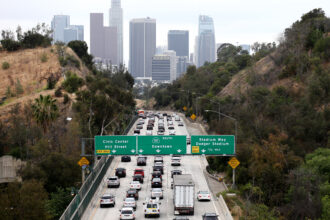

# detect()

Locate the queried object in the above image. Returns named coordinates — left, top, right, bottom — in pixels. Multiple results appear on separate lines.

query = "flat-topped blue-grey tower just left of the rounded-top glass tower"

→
left=167, top=30, right=189, bottom=57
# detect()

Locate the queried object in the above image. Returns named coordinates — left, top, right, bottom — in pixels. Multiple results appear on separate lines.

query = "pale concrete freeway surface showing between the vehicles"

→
left=82, top=111, right=221, bottom=220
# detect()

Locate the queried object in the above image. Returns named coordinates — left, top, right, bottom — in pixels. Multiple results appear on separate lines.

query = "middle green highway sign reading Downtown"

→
left=137, top=135, right=187, bottom=155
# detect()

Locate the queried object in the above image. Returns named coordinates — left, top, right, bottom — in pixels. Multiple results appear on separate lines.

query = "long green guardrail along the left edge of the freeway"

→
left=60, top=115, right=138, bottom=220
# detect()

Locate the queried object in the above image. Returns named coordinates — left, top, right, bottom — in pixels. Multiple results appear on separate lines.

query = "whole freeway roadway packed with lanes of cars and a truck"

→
left=83, top=112, right=218, bottom=220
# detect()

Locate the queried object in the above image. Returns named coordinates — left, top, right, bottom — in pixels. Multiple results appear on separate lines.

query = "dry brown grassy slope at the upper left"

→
left=0, top=46, right=88, bottom=121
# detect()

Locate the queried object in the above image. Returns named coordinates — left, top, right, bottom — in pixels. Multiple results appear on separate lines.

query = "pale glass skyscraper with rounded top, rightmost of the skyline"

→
left=195, top=15, right=216, bottom=67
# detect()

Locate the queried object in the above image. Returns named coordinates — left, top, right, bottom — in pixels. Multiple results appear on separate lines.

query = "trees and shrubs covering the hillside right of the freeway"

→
left=151, top=9, right=330, bottom=219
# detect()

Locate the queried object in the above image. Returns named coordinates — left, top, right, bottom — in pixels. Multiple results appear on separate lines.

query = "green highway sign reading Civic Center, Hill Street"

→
left=95, top=135, right=136, bottom=155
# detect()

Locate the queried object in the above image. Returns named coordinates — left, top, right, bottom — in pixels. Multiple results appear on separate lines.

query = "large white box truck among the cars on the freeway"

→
left=173, top=174, right=195, bottom=215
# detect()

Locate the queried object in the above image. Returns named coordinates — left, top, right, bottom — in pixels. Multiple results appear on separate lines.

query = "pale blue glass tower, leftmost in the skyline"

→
left=51, top=15, right=70, bottom=42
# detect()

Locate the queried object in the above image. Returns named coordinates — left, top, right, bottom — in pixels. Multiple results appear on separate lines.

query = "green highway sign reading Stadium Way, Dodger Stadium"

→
left=191, top=135, right=235, bottom=155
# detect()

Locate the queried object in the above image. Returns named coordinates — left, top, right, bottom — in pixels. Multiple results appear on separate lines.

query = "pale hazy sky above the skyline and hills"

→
left=0, top=0, right=330, bottom=63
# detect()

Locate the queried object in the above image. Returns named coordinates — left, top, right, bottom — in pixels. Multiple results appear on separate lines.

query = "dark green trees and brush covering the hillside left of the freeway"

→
left=0, top=32, right=135, bottom=219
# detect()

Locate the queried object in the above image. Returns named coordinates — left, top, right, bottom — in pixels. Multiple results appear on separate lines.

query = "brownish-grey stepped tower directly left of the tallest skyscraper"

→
left=90, top=13, right=118, bottom=65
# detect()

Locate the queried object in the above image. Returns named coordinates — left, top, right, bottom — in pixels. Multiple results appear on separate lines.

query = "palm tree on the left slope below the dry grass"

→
left=32, top=95, right=58, bottom=132
